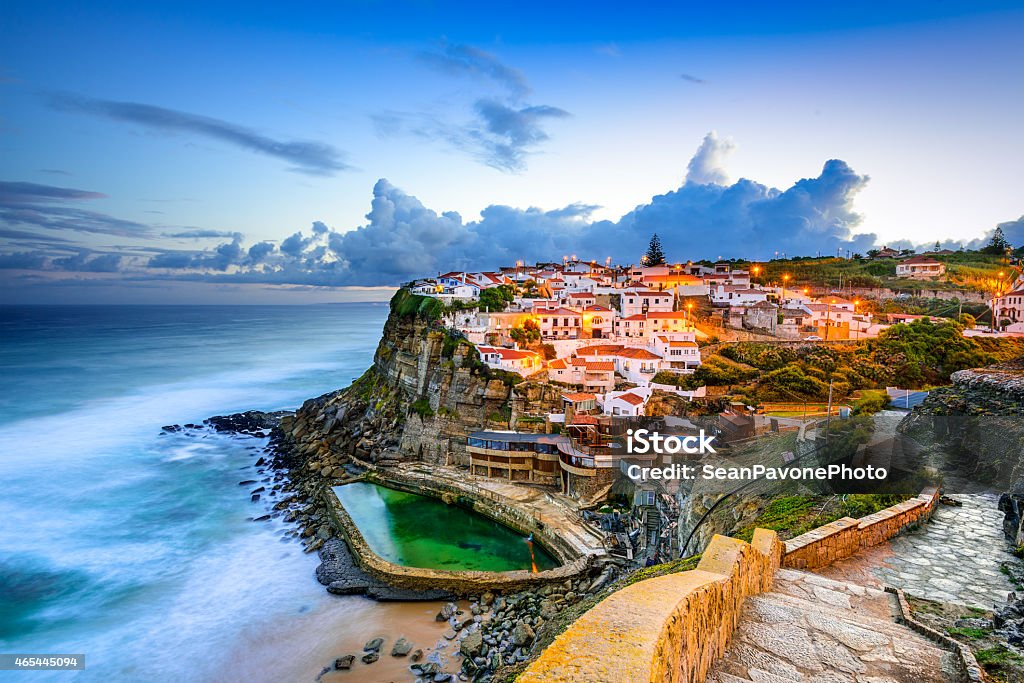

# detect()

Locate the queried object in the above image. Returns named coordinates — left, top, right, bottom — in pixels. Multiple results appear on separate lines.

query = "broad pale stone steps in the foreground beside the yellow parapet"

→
left=707, top=569, right=955, bottom=683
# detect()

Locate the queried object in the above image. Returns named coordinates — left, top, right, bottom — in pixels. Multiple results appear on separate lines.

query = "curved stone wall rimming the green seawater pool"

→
left=323, top=473, right=593, bottom=595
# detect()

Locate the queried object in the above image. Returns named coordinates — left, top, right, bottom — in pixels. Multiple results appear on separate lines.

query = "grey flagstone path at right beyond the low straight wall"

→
left=819, top=494, right=1019, bottom=609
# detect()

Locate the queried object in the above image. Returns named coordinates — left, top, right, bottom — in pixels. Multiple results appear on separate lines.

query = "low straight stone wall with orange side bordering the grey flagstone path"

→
left=782, top=488, right=939, bottom=569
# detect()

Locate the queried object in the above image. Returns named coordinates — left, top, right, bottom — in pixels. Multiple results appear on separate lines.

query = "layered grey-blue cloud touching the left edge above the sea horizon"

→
left=0, top=181, right=150, bottom=236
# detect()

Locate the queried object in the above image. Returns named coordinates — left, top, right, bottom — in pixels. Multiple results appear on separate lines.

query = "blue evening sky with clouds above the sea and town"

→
left=0, top=0, right=1024, bottom=303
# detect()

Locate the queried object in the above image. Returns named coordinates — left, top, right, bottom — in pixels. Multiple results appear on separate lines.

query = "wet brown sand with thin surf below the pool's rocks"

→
left=214, top=596, right=468, bottom=683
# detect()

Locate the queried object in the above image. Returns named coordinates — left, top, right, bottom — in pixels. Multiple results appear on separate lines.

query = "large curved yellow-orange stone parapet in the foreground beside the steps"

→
left=517, top=528, right=782, bottom=683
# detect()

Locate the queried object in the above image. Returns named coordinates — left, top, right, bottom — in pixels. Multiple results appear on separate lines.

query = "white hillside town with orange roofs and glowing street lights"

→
left=407, top=236, right=1024, bottom=417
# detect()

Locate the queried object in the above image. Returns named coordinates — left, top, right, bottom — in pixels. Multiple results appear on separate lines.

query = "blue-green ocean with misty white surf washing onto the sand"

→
left=0, top=303, right=460, bottom=681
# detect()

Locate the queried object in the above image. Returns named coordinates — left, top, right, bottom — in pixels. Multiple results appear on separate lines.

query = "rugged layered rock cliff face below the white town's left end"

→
left=275, top=306, right=559, bottom=479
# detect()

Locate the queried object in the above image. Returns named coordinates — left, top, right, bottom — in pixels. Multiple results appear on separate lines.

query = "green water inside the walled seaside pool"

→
left=334, top=481, right=558, bottom=571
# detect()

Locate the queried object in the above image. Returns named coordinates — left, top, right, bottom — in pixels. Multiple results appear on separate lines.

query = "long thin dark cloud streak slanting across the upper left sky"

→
left=49, top=94, right=351, bottom=175
